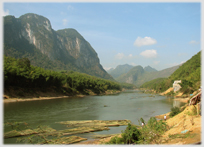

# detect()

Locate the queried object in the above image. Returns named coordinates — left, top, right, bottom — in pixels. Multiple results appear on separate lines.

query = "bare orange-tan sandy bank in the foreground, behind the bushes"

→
left=75, top=105, right=201, bottom=145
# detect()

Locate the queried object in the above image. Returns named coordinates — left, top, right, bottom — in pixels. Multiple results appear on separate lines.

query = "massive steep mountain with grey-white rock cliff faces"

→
left=4, top=13, right=113, bottom=80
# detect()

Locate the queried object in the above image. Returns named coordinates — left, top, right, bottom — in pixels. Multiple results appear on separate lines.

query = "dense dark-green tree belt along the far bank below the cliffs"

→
left=4, top=56, right=121, bottom=94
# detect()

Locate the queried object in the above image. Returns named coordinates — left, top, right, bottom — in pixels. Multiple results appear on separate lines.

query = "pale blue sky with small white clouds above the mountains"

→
left=3, top=2, right=201, bottom=70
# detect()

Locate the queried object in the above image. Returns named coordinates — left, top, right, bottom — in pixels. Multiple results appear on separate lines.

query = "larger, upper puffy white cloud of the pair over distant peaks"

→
left=134, top=37, right=157, bottom=47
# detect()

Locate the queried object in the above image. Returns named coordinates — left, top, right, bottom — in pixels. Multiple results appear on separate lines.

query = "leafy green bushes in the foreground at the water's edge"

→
left=106, top=117, right=168, bottom=144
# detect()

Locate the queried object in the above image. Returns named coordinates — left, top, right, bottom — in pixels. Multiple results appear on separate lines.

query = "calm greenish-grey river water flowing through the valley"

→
left=4, top=90, right=183, bottom=144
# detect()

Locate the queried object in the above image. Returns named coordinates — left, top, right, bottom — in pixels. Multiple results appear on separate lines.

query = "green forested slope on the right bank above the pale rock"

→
left=141, top=51, right=201, bottom=93
